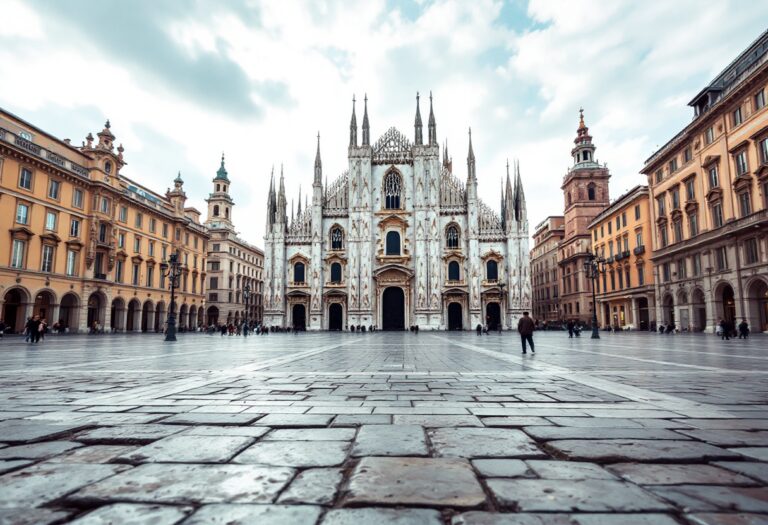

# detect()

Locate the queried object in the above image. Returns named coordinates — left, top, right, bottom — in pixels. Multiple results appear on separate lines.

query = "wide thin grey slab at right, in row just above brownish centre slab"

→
left=547, top=439, right=740, bottom=462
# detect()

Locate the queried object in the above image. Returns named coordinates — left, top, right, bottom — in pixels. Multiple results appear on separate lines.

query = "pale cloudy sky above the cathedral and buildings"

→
left=0, top=0, right=768, bottom=246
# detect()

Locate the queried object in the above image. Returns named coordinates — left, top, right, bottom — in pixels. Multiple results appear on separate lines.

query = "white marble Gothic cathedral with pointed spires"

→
left=264, top=94, right=531, bottom=330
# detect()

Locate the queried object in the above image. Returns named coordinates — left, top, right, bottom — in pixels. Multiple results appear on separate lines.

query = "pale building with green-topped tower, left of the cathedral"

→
left=205, top=155, right=264, bottom=326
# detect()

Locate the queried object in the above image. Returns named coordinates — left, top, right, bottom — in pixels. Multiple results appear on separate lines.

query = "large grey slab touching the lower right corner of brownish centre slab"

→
left=487, top=479, right=670, bottom=512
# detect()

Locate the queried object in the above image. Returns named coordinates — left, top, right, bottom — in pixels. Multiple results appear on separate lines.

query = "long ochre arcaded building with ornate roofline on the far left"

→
left=0, top=109, right=208, bottom=332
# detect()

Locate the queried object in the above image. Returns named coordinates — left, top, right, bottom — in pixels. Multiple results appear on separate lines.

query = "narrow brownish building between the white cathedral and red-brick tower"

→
left=531, top=215, right=565, bottom=324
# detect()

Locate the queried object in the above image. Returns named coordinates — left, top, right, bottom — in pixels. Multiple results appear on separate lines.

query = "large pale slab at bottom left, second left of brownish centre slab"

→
left=67, top=463, right=294, bottom=505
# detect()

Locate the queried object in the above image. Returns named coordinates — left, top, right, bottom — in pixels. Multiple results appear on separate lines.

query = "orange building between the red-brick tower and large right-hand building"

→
left=589, top=186, right=656, bottom=330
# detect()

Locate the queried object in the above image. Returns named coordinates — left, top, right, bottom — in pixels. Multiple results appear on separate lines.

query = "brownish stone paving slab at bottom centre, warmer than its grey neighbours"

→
left=345, top=457, right=485, bottom=508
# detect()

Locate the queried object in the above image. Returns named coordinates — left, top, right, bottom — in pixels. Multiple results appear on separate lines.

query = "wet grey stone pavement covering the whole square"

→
left=0, top=332, right=768, bottom=525
